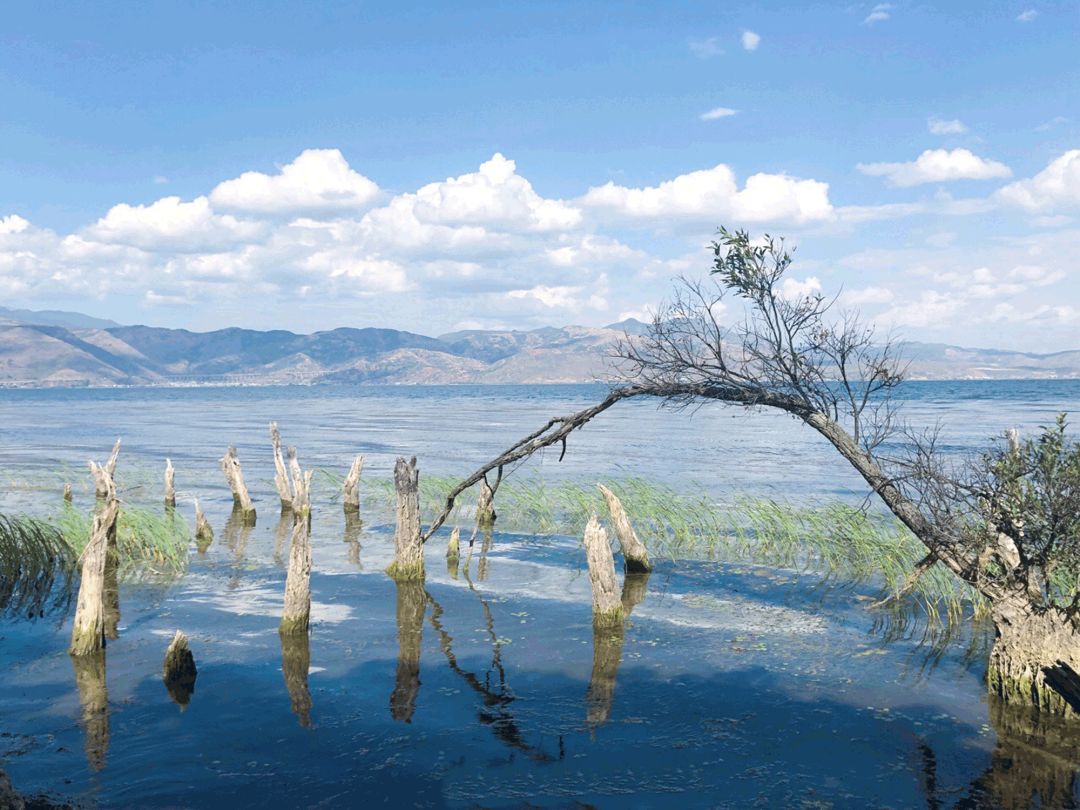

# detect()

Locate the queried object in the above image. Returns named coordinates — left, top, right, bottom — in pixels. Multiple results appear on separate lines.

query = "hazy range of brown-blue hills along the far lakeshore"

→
left=0, top=309, right=1080, bottom=387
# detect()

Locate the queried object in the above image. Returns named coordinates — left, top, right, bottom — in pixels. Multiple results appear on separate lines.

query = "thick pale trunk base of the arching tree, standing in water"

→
left=986, top=594, right=1080, bottom=717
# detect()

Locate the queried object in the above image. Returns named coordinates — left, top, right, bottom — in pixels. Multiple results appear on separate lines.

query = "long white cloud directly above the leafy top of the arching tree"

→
left=581, top=163, right=833, bottom=226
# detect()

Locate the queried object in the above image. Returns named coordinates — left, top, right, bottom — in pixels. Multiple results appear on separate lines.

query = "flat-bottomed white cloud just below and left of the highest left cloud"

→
left=86, top=197, right=265, bottom=253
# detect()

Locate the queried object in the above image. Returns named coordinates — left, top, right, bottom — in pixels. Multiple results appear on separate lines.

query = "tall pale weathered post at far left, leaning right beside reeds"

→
left=68, top=461, right=120, bottom=656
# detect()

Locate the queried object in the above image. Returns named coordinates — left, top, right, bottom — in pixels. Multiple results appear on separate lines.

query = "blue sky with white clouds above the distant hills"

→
left=0, top=2, right=1080, bottom=351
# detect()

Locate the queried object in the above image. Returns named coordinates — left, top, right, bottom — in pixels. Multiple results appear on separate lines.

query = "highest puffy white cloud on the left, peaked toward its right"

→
left=210, top=149, right=379, bottom=215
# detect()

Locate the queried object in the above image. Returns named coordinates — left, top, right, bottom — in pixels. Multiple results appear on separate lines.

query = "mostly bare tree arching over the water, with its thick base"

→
left=423, top=229, right=1080, bottom=716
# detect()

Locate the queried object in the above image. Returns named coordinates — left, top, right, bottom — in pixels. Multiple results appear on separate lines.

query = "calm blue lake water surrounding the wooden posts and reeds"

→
left=0, top=381, right=1080, bottom=808
